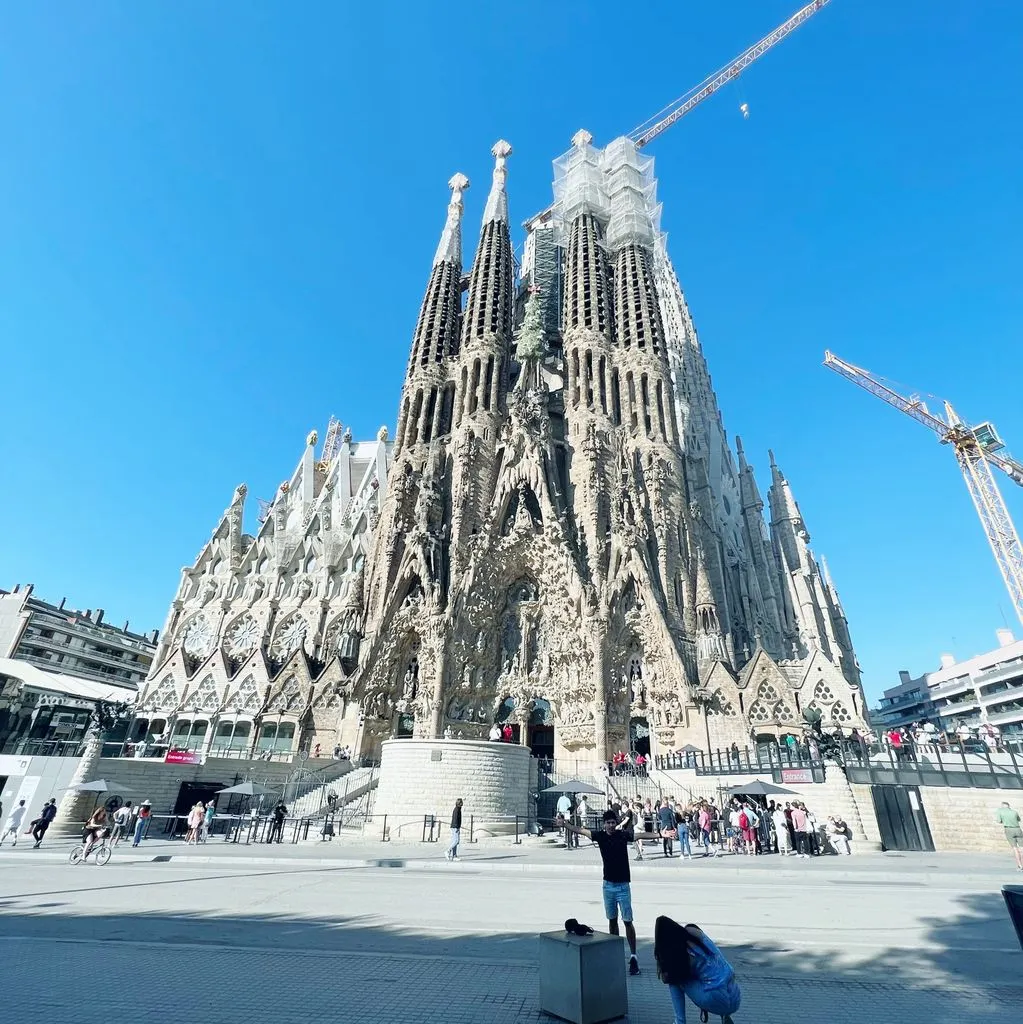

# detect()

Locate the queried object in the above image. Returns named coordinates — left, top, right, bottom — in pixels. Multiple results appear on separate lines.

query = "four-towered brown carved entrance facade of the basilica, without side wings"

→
left=354, top=132, right=697, bottom=760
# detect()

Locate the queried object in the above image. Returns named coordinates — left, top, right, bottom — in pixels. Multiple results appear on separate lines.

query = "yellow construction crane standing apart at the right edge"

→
left=824, top=352, right=1023, bottom=623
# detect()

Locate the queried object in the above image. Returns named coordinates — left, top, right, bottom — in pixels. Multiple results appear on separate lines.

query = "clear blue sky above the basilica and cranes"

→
left=0, top=0, right=1023, bottom=696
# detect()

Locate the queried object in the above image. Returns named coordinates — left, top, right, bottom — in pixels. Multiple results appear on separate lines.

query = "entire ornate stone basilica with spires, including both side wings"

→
left=136, top=131, right=865, bottom=761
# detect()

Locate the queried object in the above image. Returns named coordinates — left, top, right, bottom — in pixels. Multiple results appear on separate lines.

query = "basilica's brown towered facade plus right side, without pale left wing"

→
left=352, top=132, right=863, bottom=760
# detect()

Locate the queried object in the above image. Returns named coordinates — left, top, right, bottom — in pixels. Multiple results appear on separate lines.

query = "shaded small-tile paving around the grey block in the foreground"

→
left=0, top=940, right=1011, bottom=1024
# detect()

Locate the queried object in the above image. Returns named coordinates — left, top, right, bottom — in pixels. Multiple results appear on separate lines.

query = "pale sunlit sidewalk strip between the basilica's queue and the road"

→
left=0, top=838, right=1023, bottom=889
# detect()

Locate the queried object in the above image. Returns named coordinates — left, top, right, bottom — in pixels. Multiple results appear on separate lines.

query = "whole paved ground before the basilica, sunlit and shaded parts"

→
left=0, top=844, right=1023, bottom=1024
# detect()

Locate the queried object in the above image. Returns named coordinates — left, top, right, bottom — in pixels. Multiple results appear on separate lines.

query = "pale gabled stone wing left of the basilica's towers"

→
left=134, top=421, right=391, bottom=757
